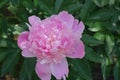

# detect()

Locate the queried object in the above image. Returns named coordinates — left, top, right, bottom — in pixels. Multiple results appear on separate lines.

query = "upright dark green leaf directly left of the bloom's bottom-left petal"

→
left=19, top=58, right=36, bottom=80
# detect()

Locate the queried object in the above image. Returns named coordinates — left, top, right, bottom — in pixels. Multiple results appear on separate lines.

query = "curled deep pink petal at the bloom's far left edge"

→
left=17, top=31, right=29, bottom=49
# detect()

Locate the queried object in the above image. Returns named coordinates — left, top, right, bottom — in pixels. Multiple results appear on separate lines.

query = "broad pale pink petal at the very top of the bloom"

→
left=57, top=11, right=74, bottom=29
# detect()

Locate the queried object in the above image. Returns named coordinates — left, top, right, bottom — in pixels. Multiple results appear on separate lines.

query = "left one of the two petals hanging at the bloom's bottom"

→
left=35, top=61, right=51, bottom=80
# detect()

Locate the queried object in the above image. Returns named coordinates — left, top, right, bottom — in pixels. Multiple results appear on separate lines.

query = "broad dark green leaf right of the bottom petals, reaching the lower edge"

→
left=70, top=59, right=92, bottom=80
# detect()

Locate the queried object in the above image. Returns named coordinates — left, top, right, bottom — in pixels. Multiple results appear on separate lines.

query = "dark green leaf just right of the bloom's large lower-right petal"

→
left=85, top=46, right=102, bottom=63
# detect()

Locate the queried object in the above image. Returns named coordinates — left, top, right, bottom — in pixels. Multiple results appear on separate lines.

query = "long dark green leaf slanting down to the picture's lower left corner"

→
left=1, top=50, right=19, bottom=76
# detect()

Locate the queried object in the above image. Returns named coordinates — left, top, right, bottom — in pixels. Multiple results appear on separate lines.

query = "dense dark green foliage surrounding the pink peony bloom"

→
left=0, top=0, right=120, bottom=80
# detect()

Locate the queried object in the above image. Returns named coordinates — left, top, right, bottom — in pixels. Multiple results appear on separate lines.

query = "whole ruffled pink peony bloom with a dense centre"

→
left=18, top=11, right=85, bottom=80
